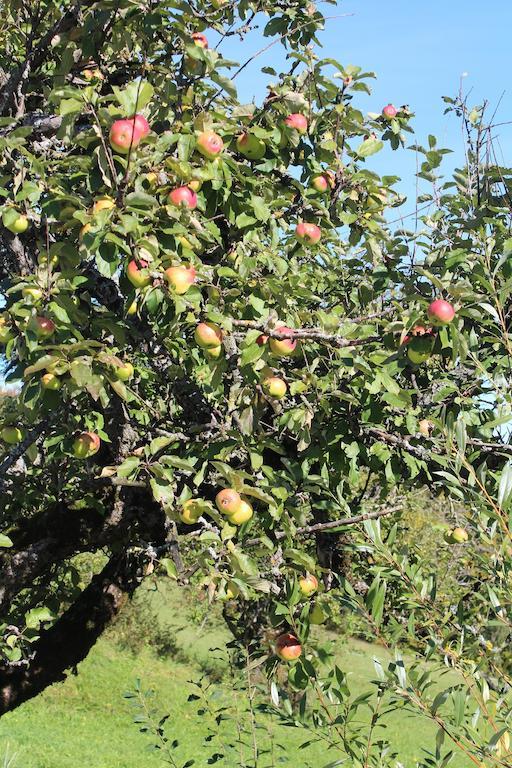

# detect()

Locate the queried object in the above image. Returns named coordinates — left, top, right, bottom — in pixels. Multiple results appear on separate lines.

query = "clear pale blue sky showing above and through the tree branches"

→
left=222, top=0, right=512, bottom=204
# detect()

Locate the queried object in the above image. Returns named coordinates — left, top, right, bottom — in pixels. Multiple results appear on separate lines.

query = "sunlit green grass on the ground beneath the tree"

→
left=0, top=589, right=464, bottom=768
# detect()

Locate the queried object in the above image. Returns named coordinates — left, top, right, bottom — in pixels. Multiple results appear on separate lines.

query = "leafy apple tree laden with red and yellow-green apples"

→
left=0, top=0, right=512, bottom=764
